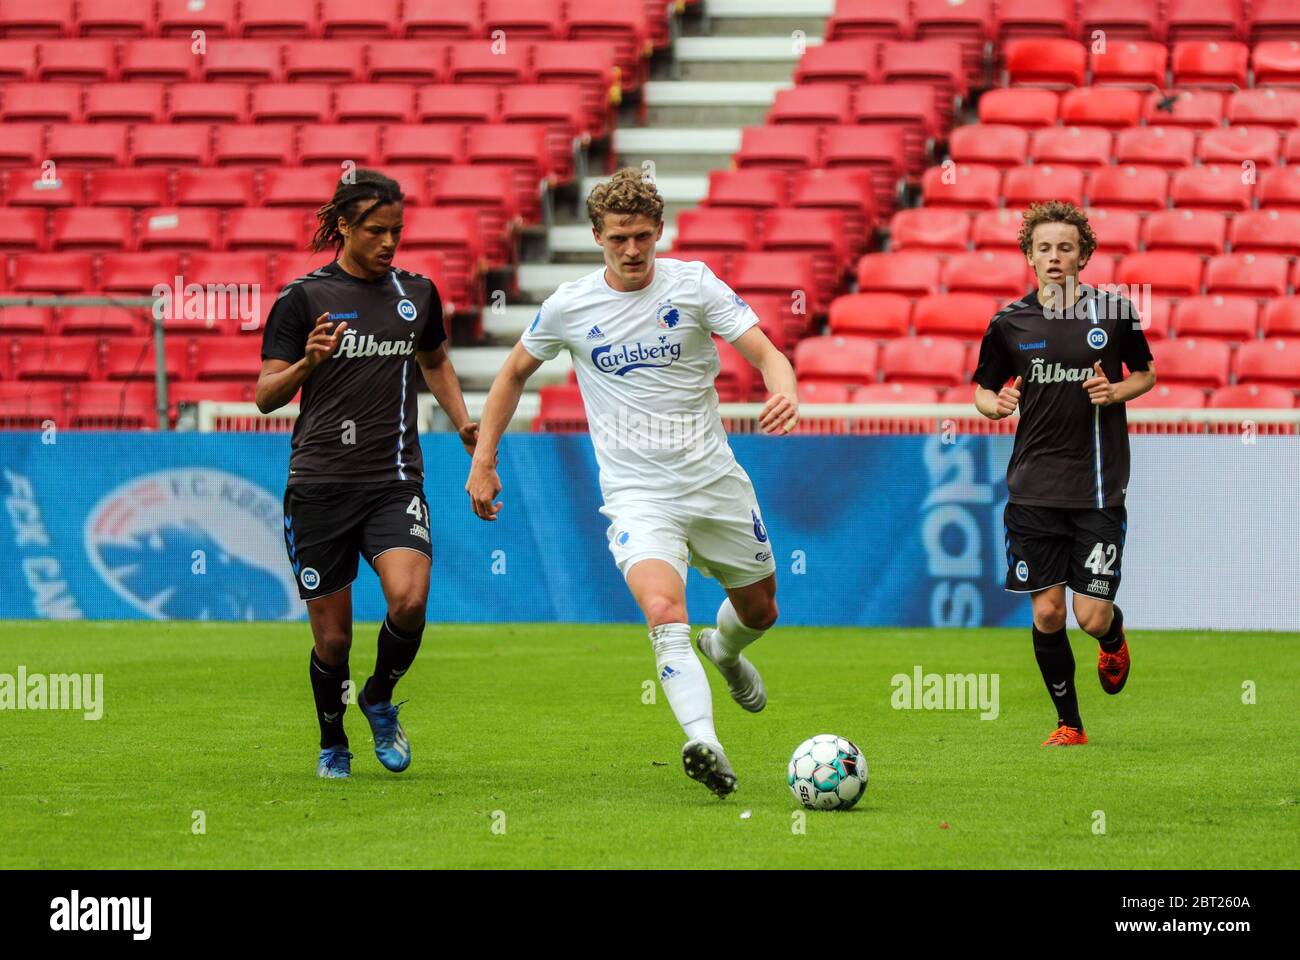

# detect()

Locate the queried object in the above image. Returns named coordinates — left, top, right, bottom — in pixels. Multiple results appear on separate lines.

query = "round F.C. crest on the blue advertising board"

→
left=83, top=467, right=303, bottom=620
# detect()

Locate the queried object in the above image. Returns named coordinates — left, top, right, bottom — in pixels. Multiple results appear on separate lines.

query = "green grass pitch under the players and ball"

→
left=0, top=622, right=1300, bottom=869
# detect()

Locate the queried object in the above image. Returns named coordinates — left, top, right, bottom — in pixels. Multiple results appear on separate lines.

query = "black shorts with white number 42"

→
left=1002, top=503, right=1128, bottom=602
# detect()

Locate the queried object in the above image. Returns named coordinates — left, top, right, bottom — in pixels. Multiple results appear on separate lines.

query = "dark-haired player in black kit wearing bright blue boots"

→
left=257, top=170, right=478, bottom=778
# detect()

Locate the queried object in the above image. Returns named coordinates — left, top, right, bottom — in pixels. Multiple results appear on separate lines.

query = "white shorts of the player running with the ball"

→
left=601, top=464, right=776, bottom=589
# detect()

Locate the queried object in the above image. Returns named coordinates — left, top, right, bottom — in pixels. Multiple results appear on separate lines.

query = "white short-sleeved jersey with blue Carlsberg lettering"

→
left=521, top=259, right=758, bottom=502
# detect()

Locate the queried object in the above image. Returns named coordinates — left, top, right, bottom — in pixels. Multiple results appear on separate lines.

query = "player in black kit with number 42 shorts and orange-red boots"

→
left=975, top=200, right=1156, bottom=747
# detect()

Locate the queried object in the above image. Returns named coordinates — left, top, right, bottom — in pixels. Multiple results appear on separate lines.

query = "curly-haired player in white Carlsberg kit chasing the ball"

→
left=465, top=168, right=798, bottom=796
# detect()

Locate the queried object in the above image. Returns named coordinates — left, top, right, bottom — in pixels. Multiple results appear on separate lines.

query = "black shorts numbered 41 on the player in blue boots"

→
left=285, top=480, right=433, bottom=600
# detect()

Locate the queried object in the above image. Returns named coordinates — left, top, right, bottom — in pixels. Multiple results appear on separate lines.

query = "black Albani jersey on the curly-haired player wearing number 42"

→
left=975, top=284, right=1151, bottom=509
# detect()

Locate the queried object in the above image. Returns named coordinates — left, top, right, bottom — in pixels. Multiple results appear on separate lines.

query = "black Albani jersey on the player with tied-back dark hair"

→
left=261, top=263, right=446, bottom=484
